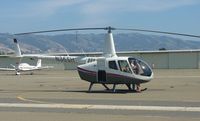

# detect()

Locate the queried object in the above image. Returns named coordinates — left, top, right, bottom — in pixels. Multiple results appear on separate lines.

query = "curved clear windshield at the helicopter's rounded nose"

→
left=128, top=58, right=152, bottom=76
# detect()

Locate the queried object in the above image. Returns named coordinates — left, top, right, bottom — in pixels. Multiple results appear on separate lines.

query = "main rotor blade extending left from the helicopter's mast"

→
left=14, top=27, right=108, bottom=35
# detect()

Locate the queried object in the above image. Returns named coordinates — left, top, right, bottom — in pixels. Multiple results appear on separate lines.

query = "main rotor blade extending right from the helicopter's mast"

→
left=115, top=28, right=200, bottom=38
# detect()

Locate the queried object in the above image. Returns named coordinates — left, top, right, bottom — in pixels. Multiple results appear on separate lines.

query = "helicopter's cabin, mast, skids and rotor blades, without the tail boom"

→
left=15, top=26, right=200, bottom=92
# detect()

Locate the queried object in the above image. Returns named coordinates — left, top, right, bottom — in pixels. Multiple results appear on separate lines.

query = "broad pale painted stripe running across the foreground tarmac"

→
left=0, top=103, right=200, bottom=112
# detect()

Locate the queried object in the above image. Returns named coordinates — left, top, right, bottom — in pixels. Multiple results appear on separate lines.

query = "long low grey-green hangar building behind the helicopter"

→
left=0, top=50, right=200, bottom=70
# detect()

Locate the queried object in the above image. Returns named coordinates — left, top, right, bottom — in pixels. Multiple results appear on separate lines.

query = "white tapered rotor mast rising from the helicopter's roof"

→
left=104, top=27, right=117, bottom=57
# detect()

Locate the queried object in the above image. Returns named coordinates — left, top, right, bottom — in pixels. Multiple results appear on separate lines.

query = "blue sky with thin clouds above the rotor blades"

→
left=0, top=0, right=200, bottom=35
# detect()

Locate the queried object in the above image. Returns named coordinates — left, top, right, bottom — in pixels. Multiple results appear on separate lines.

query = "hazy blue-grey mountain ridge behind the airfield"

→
left=0, top=33, right=200, bottom=53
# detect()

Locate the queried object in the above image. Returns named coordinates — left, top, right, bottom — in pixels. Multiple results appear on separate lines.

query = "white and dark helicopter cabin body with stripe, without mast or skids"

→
left=77, top=57, right=153, bottom=84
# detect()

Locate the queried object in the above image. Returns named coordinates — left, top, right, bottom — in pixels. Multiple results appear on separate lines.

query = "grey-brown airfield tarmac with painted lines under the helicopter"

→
left=0, top=69, right=200, bottom=121
